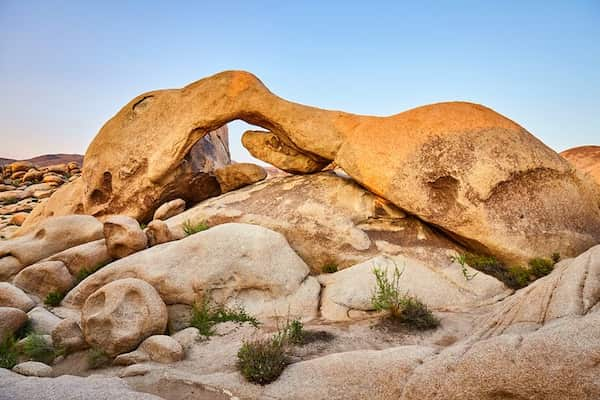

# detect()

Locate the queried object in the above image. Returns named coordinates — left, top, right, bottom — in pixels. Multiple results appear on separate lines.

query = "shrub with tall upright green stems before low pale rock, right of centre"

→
left=371, top=267, right=440, bottom=330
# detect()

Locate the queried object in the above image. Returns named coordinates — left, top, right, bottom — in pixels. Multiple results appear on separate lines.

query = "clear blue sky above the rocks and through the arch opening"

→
left=0, top=0, right=600, bottom=160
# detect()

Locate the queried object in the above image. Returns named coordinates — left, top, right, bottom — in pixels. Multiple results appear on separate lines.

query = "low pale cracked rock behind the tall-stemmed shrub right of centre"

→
left=319, top=256, right=511, bottom=320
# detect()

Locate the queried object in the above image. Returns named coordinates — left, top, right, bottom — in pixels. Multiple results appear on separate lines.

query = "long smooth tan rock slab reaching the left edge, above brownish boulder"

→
left=0, top=215, right=103, bottom=279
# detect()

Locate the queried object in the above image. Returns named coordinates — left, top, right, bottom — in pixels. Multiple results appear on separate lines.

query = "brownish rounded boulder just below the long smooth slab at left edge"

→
left=13, top=261, right=74, bottom=299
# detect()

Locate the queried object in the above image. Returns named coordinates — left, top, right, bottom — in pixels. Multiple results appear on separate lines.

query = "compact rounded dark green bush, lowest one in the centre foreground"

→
left=237, top=338, right=289, bottom=385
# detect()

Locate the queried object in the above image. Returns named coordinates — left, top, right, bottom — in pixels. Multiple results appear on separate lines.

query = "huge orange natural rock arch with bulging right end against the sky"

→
left=16, top=71, right=600, bottom=262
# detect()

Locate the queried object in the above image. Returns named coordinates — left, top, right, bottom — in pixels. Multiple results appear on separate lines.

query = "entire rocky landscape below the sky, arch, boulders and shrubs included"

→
left=0, top=72, right=600, bottom=400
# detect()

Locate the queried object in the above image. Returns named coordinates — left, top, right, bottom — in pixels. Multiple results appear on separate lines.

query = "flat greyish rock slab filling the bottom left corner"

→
left=0, top=368, right=161, bottom=400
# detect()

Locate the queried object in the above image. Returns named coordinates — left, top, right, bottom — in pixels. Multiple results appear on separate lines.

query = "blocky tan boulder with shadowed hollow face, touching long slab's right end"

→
left=104, top=215, right=148, bottom=258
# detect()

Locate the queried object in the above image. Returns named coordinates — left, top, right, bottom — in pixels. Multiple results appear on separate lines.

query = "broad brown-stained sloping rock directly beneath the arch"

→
left=166, top=173, right=461, bottom=273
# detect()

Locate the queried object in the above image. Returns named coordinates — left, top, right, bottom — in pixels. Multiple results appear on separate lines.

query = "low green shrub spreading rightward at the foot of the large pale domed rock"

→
left=190, top=299, right=259, bottom=336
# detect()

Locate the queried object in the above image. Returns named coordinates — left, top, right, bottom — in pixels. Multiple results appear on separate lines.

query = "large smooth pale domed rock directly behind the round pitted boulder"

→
left=63, top=224, right=320, bottom=318
